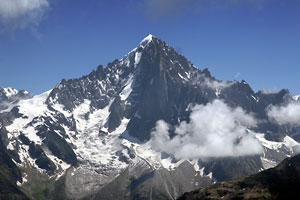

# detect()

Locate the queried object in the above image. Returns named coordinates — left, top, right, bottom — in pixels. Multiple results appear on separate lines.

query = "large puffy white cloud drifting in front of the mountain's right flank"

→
left=150, top=100, right=262, bottom=159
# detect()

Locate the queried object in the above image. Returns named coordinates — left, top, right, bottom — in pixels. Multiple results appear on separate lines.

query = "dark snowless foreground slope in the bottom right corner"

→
left=179, top=154, right=300, bottom=200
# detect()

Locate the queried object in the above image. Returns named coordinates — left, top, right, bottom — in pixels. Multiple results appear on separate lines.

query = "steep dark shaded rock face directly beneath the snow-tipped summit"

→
left=124, top=39, right=214, bottom=141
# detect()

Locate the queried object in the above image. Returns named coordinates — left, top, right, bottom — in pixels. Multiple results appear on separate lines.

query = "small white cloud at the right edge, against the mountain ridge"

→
left=267, top=101, right=300, bottom=126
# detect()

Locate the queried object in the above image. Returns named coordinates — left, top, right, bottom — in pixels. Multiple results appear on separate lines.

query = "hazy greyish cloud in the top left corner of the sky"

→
left=0, top=0, right=49, bottom=32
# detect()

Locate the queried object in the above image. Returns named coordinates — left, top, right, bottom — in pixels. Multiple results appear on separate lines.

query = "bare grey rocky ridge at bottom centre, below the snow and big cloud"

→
left=90, top=160, right=212, bottom=200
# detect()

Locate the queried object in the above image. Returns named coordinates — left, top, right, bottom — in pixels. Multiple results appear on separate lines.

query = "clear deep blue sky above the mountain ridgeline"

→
left=0, top=0, right=300, bottom=94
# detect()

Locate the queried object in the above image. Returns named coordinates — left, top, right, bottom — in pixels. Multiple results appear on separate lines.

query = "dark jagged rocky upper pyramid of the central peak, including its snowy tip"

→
left=47, top=35, right=218, bottom=141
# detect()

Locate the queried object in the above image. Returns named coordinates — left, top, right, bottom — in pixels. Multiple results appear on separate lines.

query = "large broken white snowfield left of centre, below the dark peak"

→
left=72, top=100, right=129, bottom=171
